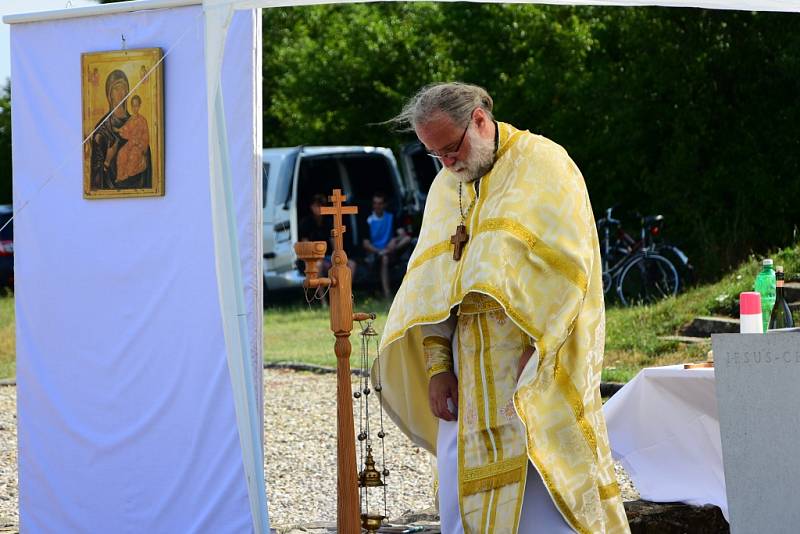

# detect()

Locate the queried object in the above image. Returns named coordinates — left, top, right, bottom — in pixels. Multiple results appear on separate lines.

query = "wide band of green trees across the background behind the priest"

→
left=263, top=3, right=800, bottom=277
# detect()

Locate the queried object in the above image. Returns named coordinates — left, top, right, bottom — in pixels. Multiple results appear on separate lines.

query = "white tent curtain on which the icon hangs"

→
left=11, top=0, right=266, bottom=532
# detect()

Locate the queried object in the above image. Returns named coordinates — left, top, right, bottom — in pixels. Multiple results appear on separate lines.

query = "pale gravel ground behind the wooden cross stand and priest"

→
left=0, top=370, right=638, bottom=533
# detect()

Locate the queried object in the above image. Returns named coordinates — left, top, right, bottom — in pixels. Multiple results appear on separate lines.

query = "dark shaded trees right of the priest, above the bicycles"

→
left=554, top=8, right=800, bottom=277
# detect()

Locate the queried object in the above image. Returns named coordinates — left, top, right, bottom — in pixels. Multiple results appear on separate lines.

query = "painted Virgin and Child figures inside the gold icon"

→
left=91, top=70, right=153, bottom=189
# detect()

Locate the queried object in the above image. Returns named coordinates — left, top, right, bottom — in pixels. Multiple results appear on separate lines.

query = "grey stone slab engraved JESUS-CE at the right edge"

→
left=712, top=329, right=800, bottom=534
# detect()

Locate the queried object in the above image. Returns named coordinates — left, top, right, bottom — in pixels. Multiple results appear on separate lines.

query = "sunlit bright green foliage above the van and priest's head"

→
left=263, top=3, right=591, bottom=146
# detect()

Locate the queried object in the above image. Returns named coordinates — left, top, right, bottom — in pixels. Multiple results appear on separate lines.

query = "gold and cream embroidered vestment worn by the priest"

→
left=373, top=123, right=629, bottom=534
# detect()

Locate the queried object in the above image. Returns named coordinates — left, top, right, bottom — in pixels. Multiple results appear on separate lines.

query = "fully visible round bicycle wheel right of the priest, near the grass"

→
left=617, top=254, right=680, bottom=306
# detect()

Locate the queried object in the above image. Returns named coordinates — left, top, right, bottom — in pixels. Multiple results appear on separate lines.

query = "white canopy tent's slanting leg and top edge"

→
left=4, top=0, right=800, bottom=533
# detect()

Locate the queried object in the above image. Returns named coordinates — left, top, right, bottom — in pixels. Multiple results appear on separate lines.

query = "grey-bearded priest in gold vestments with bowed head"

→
left=373, top=83, right=630, bottom=534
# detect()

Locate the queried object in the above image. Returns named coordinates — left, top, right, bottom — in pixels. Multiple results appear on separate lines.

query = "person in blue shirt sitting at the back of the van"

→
left=364, top=193, right=411, bottom=298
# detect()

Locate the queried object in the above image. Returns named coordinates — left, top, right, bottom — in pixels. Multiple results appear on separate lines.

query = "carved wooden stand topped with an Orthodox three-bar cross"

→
left=294, top=189, right=368, bottom=534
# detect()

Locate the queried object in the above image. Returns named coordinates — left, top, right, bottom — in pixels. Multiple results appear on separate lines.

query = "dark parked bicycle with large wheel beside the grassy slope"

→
left=597, top=207, right=680, bottom=306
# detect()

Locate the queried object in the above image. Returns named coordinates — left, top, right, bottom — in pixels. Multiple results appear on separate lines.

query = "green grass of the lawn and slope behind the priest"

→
left=0, top=246, right=800, bottom=382
